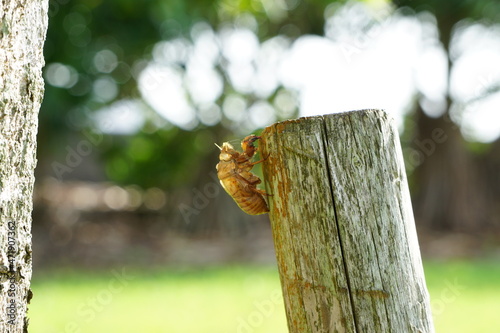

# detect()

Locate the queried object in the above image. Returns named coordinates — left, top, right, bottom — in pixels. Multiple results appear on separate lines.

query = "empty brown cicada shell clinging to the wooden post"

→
left=216, top=134, right=269, bottom=215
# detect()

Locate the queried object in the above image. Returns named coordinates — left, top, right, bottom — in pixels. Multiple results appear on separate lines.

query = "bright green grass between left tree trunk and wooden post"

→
left=29, top=267, right=286, bottom=333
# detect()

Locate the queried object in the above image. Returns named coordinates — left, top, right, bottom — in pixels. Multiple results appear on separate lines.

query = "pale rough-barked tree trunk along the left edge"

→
left=0, top=0, right=48, bottom=332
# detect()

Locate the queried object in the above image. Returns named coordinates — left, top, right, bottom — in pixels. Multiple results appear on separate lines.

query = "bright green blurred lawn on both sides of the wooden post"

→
left=29, top=262, right=500, bottom=333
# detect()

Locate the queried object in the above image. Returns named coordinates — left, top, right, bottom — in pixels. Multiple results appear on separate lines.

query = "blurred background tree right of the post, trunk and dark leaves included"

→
left=394, top=0, right=500, bottom=231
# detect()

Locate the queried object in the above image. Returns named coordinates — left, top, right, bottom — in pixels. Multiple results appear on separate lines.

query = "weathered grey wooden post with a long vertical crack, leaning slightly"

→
left=261, top=110, right=434, bottom=333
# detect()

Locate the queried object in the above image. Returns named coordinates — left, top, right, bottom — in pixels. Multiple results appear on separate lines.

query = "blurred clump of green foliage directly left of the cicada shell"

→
left=102, top=127, right=217, bottom=188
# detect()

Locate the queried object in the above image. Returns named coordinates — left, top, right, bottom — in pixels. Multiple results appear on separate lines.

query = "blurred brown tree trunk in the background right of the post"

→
left=410, top=108, right=495, bottom=232
